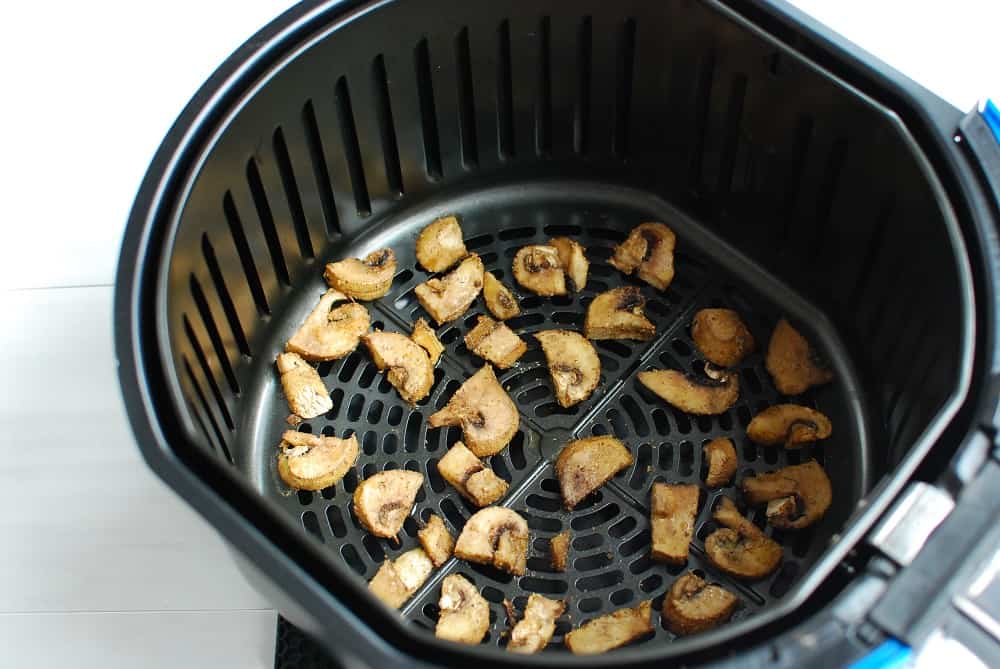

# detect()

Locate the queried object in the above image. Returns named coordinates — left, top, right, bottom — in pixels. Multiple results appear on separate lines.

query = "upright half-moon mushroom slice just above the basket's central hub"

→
left=535, top=330, right=601, bottom=407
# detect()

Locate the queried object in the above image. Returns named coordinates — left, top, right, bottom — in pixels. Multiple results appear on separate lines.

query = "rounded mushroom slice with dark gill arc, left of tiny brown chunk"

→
left=455, top=506, right=528, bottom=576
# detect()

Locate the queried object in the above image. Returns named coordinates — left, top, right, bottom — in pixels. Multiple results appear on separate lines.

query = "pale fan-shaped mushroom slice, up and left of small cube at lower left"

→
left=354, top=469, right=424, bottom=539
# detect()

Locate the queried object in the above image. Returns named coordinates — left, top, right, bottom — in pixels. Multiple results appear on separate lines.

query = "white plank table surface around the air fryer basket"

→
left=0, top=0, right=1000, bottom=669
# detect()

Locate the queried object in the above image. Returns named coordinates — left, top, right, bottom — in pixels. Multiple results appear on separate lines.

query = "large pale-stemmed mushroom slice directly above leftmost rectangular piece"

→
left=285, top=288, right=370, bottom=361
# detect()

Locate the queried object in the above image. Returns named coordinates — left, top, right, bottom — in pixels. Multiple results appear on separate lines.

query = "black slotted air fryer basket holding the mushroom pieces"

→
left=117, top=0, right=992, bottom=664
